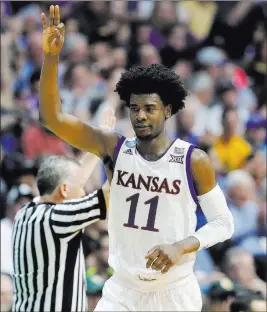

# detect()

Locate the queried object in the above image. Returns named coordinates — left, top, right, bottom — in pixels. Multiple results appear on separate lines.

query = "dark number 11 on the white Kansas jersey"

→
left=123, top=193, right=159, bottom=232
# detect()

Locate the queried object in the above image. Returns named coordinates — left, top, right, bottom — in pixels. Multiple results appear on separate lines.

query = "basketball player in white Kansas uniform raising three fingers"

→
left=40, top=6, right=233, bottom=311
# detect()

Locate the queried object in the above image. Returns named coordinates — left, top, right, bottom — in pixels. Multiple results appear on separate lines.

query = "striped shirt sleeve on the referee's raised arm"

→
left=51, top=189, right=106, bottom=235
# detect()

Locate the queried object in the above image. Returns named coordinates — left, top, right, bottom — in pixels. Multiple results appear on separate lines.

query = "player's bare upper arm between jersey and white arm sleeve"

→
left=191, top=148, right=216, bottom=195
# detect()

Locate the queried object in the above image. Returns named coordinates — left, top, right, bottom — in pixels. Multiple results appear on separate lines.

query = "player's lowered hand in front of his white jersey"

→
left=145, top=244, right=184, bottom=274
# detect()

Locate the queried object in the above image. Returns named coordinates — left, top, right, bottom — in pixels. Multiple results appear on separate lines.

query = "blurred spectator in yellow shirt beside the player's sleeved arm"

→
left=213, top=108, right=252, bottom=173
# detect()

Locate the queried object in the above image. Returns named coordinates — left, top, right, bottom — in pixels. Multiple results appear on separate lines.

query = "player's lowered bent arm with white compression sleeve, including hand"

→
left=145, top=149, right=234, bottom=274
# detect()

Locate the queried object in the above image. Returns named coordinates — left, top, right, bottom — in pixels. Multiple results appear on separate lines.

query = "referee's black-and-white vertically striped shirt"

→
left=12, top=190, right=106, bottom=312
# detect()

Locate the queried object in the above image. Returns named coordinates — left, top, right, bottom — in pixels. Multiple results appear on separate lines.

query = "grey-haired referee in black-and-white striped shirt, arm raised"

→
left=12, top=109, right=116, bottom=312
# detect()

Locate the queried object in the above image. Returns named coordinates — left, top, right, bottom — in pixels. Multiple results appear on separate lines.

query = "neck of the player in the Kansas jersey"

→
left=137, top=131, right=172, bottom=160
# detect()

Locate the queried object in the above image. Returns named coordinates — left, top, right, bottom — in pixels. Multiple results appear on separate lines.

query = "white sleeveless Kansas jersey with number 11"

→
left=108, top=139, right=197, bottom=283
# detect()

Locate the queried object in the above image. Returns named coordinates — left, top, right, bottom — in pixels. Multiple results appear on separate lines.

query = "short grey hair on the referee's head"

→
left=36, top=155, right=80, bottom=196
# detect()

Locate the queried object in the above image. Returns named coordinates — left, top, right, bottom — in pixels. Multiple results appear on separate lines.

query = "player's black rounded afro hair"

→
left=115, top=64, right=188, bottom=115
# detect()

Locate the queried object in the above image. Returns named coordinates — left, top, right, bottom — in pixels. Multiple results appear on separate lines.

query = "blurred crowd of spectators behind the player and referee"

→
left=0, top=0, right=267, bottom=312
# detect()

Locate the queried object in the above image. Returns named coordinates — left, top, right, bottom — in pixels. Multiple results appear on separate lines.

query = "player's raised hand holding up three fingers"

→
left=41, top=5, right=65, bottom=55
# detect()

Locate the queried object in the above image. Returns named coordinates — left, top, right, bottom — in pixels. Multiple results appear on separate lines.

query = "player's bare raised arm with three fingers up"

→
left=39, top=5, right=119, bottom=157
